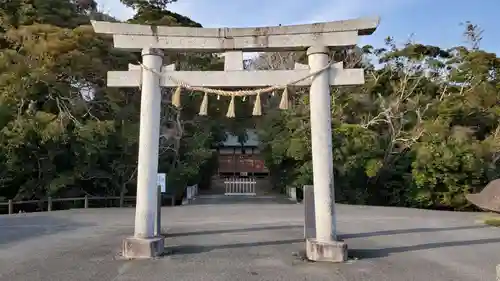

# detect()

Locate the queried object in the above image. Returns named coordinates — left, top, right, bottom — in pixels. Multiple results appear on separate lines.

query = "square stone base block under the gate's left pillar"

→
left=122, top=237, right=165, bottom=259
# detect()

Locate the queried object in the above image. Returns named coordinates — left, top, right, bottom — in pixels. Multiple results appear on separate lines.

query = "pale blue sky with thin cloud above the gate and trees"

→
left=98, top=0, right=500, bottom=53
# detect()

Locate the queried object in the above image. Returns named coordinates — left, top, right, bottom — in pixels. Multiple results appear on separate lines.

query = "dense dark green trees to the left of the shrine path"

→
left=0, top=0, right=230, bottom=205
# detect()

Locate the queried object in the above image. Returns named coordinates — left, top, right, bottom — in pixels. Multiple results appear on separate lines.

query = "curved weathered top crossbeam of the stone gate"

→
left=92, top=18, right=379, bottom=53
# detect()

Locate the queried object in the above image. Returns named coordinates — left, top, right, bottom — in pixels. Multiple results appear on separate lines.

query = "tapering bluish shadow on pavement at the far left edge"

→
left=0, top=215, right=91, bottom=247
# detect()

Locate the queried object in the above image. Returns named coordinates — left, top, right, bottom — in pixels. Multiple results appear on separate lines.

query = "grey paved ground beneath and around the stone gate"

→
left=0, top=195, right=500, bottom=281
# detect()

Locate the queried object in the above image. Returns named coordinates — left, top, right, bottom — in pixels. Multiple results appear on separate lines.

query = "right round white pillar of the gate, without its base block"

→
left=307, top=46, right=336, bottom=242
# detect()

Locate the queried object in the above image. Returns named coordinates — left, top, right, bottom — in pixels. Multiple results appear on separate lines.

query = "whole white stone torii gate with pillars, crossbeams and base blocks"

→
left=92, top=18, right=379, bottom=262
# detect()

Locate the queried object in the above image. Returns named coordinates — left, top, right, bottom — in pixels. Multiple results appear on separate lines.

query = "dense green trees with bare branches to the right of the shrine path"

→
left=260, top=30, right=500, bottom=209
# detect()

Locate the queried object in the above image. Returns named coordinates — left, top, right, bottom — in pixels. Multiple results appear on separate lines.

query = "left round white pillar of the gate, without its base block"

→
left=134, top=49, right=163, bottom=238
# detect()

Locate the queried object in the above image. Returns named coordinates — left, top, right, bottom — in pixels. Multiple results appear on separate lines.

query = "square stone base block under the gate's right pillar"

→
left=306, top=238, right=347, bottom=262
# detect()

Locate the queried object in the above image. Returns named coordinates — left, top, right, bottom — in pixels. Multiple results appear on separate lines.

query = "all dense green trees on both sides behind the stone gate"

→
left=0, top=0, right=500, bottom=209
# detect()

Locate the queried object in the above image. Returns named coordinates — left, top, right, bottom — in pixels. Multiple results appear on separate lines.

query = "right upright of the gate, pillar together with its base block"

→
left=306, top=46, right=347, bottom=262
